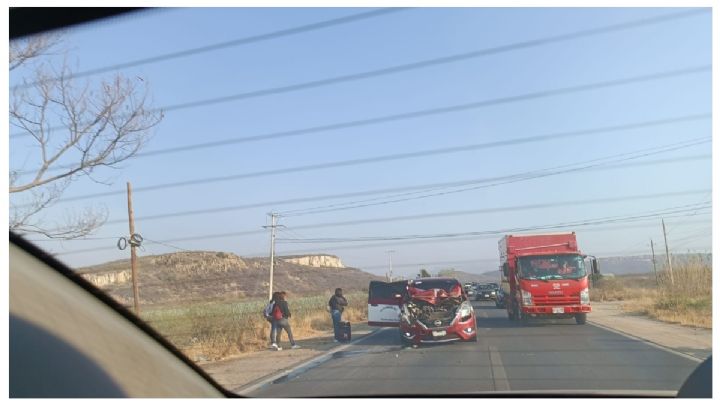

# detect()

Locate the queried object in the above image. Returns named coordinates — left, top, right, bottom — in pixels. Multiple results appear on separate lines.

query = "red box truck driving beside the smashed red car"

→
left=498, top=232, right=598, bottom=324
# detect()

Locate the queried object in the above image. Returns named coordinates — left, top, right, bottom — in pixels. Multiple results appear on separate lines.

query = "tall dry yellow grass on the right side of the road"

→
left=590, top=257, right=712, bottom=328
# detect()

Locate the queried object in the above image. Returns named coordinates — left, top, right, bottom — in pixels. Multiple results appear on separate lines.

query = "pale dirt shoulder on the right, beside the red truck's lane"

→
left=588, top=302, right=712, bottom=359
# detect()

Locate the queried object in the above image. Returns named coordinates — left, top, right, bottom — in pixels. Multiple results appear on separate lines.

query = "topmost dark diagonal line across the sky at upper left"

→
left=11, top=8, right=408, bottom=89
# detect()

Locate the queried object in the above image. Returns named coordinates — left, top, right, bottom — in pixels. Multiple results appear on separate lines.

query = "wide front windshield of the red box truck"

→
left=518, top=255, right=586, bottom=280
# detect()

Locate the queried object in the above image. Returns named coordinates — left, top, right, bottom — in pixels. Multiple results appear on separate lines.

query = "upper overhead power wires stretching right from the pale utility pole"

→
left=280, top=138, right=710, bottom=217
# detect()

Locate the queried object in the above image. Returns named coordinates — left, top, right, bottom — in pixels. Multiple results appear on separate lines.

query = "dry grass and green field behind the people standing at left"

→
left=141, top=292, right=367, bottom=361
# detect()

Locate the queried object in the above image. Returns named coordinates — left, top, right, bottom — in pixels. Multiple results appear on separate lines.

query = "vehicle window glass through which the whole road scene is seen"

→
left=8, top=5, right=720, bottom=397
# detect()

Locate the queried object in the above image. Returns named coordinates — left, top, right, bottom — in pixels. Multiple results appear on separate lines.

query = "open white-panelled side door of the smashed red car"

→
left=368, top=281, right=407, bottom=327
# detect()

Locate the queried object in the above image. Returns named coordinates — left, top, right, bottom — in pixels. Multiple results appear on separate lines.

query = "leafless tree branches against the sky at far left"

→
left=10, top=37, right=163, bottom=239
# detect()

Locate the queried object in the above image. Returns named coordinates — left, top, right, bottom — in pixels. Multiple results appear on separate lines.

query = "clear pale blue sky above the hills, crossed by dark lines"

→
left=10, top=8, right=711, bottom=274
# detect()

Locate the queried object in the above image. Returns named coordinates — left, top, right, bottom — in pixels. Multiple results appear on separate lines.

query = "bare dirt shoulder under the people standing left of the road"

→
left=198, top=323, right=376, bottom=391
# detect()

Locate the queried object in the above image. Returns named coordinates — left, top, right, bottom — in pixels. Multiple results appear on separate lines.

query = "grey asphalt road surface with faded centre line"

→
left=251, top=302, right=698, bottom=397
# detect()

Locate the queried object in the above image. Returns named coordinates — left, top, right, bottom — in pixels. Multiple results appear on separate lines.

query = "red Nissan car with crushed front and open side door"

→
left=368, top=278, right=477, bottom=346
